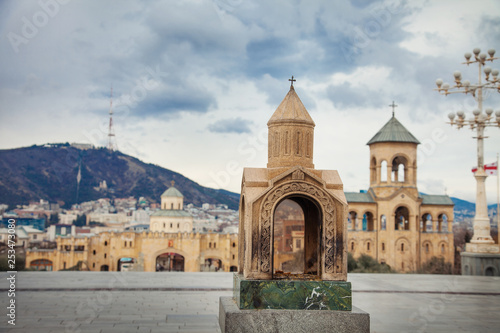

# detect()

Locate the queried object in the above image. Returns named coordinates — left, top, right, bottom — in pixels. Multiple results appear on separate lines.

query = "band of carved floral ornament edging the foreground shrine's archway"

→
left=260, top=180, right=336, bottom=273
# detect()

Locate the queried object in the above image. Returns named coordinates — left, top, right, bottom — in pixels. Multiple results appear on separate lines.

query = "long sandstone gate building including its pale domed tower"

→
left=26, top=182, right=238, bottom=272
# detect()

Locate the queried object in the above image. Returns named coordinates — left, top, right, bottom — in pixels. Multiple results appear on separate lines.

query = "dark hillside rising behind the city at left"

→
left=0, top=144, right=239, bottom=209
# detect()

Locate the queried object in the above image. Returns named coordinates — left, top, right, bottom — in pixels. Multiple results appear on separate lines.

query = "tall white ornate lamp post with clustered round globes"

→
left=435, top=48, right=500, bottom=252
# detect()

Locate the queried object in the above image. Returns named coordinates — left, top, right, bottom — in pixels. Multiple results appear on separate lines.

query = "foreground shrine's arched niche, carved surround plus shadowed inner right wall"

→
left=258, top=181, right=346, bottom=280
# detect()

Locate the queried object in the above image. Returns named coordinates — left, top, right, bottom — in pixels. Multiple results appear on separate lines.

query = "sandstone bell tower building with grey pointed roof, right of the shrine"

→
left=346, top=116, right=454, bottom=272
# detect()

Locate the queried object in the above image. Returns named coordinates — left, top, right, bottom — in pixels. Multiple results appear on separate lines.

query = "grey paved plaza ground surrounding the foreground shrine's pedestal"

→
left=0, top=272, right=500, bottom=333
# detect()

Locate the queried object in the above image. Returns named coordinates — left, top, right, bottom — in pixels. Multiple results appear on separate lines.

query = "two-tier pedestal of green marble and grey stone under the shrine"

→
left=219, top=274, right=370, bottom=333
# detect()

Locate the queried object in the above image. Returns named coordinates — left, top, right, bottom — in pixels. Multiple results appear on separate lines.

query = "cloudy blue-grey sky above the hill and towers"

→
left=0, top=0, right=500, bottom=203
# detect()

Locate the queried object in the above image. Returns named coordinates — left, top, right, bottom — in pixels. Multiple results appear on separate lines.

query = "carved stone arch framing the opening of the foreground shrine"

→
left=259, top=181, right=338, bottom=279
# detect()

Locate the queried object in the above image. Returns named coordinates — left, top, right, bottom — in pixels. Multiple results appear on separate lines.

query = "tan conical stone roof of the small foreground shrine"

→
left=267, top=85, right=315, bottom=126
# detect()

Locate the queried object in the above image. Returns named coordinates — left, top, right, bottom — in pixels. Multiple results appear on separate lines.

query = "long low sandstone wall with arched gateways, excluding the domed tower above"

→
left=26, top=231, right=238, bottom=272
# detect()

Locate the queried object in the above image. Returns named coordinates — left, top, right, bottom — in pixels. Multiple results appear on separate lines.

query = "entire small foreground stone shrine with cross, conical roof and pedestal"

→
left=219, top=81, right=370, bottom=332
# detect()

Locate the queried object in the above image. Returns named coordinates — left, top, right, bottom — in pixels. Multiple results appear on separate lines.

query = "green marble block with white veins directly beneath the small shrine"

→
left=233, top=274, right=352, bottom=311
